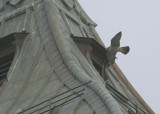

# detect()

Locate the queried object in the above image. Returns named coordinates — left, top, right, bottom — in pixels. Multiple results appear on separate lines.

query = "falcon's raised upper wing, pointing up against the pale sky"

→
left=111, top=32, right=122, bottom=47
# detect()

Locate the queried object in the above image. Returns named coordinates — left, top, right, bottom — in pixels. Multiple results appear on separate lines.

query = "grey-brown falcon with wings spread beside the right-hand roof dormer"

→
left=107, top=32, right=130, bottom=65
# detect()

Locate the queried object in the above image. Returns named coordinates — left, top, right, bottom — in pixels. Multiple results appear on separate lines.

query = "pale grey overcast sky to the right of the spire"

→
left=79, top=0, right=160, bottom=114
